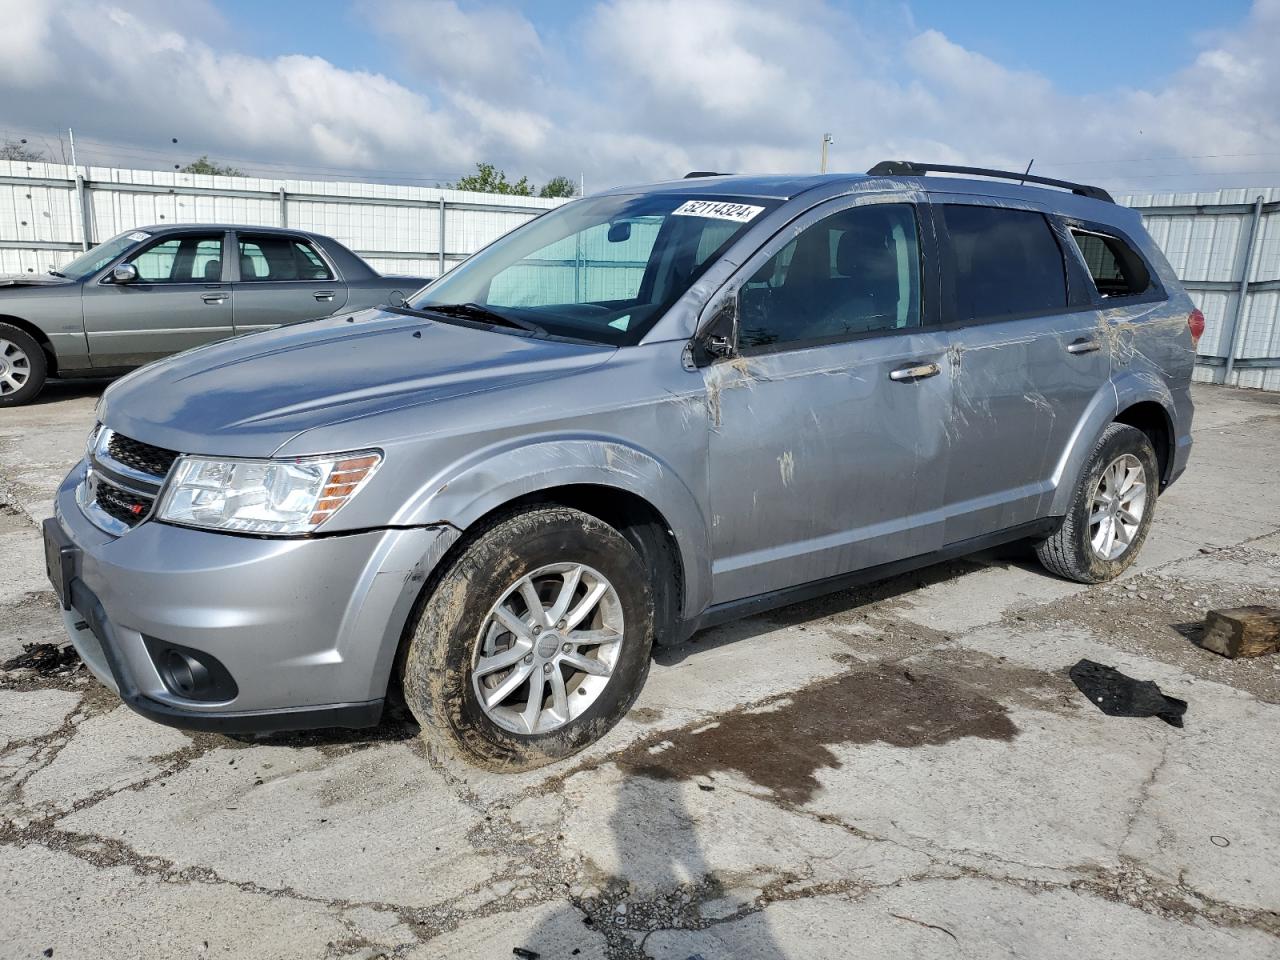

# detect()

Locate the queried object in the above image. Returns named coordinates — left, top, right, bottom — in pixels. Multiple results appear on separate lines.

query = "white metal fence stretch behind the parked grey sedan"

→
left=0, top=160, right=564, bottom=276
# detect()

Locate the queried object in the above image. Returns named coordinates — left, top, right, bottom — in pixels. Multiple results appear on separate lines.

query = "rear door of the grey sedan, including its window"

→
left=233, top=230, right=347, bottom=334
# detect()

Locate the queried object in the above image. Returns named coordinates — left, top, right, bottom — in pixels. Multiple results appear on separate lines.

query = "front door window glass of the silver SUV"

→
left=739, top=204, right=920, bottom=348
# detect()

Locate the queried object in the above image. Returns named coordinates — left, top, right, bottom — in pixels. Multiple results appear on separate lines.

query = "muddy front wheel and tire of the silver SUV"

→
left=401, top=507, right=654, bottom=771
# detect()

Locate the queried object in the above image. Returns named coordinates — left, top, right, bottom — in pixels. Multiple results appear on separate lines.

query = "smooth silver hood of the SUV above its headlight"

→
left=99, top=310, right=613, bottom=457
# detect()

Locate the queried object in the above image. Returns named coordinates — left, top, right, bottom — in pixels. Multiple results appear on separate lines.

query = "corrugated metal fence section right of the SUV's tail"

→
left=1116, top=187, right=1280, bottom=390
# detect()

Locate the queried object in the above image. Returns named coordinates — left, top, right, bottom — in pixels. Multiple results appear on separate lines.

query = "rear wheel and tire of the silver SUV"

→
left=1036, top=424, right=1160, bottom=584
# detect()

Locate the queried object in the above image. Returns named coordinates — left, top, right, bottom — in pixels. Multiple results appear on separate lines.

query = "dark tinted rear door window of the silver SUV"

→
left=943, top=204, right=1066, bottom=320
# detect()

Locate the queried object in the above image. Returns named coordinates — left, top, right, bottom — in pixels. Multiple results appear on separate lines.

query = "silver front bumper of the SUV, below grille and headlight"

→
left=55, top=465, right=457, bottom=732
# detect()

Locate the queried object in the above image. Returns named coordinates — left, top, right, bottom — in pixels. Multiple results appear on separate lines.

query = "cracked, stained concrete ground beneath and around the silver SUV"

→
left=0, top=385, right=1280, bottom=960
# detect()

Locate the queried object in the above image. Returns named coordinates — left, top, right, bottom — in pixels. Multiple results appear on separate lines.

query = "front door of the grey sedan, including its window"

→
left=82, top=229, right=234, bottom=367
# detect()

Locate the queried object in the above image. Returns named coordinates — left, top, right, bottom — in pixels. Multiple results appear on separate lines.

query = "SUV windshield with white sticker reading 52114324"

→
left=410, top=193, right=778, bottom=346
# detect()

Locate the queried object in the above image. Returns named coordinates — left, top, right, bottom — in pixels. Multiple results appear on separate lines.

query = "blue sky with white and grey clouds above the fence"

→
left=0, top=0, right=1280, bottom=192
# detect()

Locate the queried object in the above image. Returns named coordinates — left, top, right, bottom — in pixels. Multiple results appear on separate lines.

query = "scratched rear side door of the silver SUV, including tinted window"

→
left=933, top=196, right=1111, bottom=544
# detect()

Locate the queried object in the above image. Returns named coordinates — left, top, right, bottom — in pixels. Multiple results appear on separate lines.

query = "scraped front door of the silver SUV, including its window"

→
left=703, top=198, right=951, bottom=603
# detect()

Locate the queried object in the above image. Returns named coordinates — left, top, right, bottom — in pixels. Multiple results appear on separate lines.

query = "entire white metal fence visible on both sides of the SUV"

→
left=0, top=161, right=1280, bottom=390
